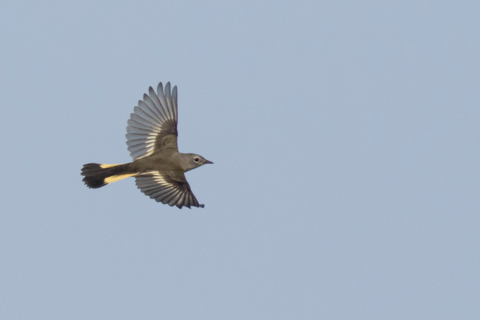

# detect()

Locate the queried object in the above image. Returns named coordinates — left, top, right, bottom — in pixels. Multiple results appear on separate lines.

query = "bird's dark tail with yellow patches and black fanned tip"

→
left=82, top=163, right=137, bottom=189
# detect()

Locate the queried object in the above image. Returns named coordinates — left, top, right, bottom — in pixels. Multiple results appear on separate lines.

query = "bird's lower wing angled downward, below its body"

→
left=135, top=171, right=204, bottom=209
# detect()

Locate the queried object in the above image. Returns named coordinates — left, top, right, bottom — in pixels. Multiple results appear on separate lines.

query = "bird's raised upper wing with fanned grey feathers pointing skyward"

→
left=126, top=82, right=178, bottom=160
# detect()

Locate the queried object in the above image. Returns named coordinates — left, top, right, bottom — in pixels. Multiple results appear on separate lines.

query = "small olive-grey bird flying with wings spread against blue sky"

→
left=81, top=82, right=213, bottom=209
